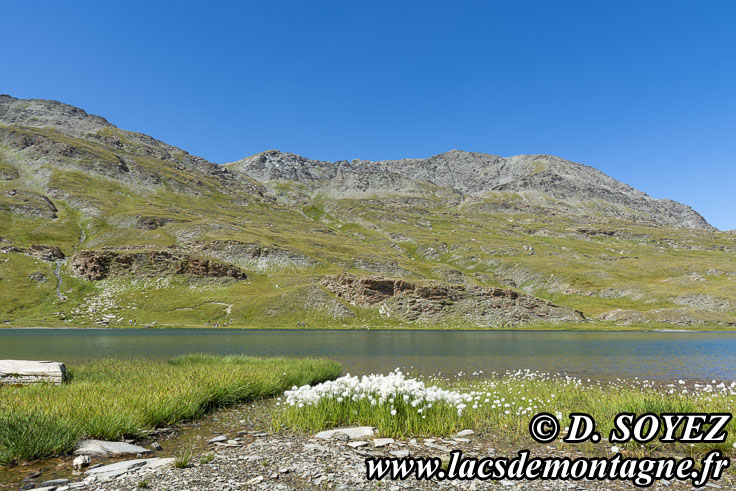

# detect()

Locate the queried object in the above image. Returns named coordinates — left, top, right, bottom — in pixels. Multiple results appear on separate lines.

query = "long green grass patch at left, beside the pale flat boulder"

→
left=0, top=355, right=340, bottom=464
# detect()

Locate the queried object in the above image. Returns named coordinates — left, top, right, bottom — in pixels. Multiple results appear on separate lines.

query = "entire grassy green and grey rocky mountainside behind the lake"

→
left=0, top=95, right=736, bottom=328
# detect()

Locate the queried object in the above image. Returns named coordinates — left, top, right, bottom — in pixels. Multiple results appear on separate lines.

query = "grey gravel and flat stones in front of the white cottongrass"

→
left=18, top=429, right=736, bottom=491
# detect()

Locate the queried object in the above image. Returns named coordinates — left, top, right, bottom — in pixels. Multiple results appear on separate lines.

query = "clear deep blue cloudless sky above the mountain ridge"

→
left=0, top=0, right=736, bottom=229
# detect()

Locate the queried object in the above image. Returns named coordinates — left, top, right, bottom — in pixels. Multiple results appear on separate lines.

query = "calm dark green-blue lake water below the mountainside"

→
left=0, top=329, right=736, bottom=380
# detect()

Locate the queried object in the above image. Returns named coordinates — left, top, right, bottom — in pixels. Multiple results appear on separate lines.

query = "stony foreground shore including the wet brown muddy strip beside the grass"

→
left=5, top=382, right=736, bottom=491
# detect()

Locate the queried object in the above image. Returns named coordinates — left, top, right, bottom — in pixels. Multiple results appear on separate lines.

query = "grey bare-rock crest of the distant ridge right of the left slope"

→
left=228, top=150, right=712, bottom=229
